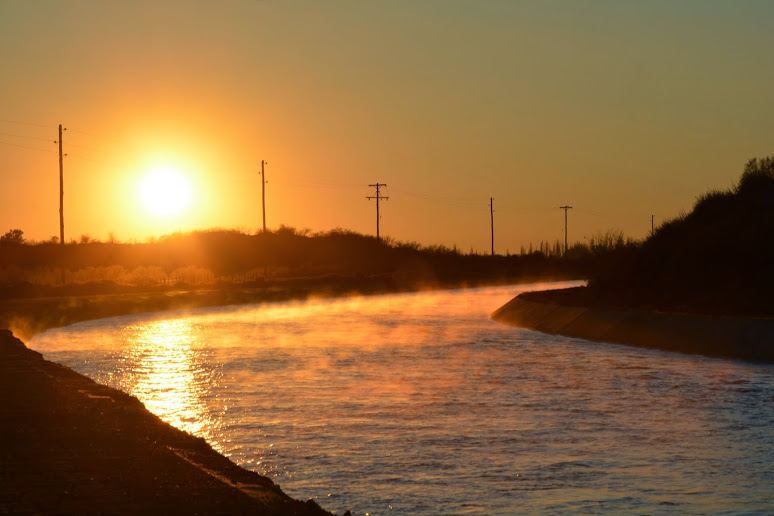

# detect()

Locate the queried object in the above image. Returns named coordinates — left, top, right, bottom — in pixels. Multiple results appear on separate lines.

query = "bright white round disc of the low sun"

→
left=140, top=167, right=191, bottom=217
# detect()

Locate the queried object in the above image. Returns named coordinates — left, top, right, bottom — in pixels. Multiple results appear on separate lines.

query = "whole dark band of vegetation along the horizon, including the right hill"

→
left=9, top=151, right=774, bottom=315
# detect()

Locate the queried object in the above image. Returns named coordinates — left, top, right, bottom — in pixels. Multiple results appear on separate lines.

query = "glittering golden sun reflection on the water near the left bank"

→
left=120, top=319, right=220, bottom=448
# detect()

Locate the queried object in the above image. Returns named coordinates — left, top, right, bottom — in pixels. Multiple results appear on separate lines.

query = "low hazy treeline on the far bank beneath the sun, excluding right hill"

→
left=0, top=227, right=608, bottom=297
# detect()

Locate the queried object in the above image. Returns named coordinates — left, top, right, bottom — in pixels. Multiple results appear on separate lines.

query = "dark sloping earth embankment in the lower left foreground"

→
left=0, top=330, right=330, bottom=515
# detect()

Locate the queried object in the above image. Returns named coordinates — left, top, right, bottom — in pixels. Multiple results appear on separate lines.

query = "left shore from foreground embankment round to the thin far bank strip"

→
left=0, top=277, right=568, bottom=515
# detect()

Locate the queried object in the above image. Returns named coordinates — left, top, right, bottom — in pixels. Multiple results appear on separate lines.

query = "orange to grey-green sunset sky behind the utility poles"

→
left=0, top=0, right=774, bottom=253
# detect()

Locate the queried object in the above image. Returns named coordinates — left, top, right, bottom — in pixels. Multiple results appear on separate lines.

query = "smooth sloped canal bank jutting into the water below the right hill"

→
left=492, top=291, right=774, bottom=363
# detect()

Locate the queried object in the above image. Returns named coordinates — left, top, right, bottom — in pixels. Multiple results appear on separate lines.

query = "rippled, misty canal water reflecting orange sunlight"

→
left=30, top=284, right=774, bottom=514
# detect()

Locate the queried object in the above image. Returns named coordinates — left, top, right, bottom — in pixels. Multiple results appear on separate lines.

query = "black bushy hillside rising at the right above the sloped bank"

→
left=586, top=157, right=774, bottom=315
